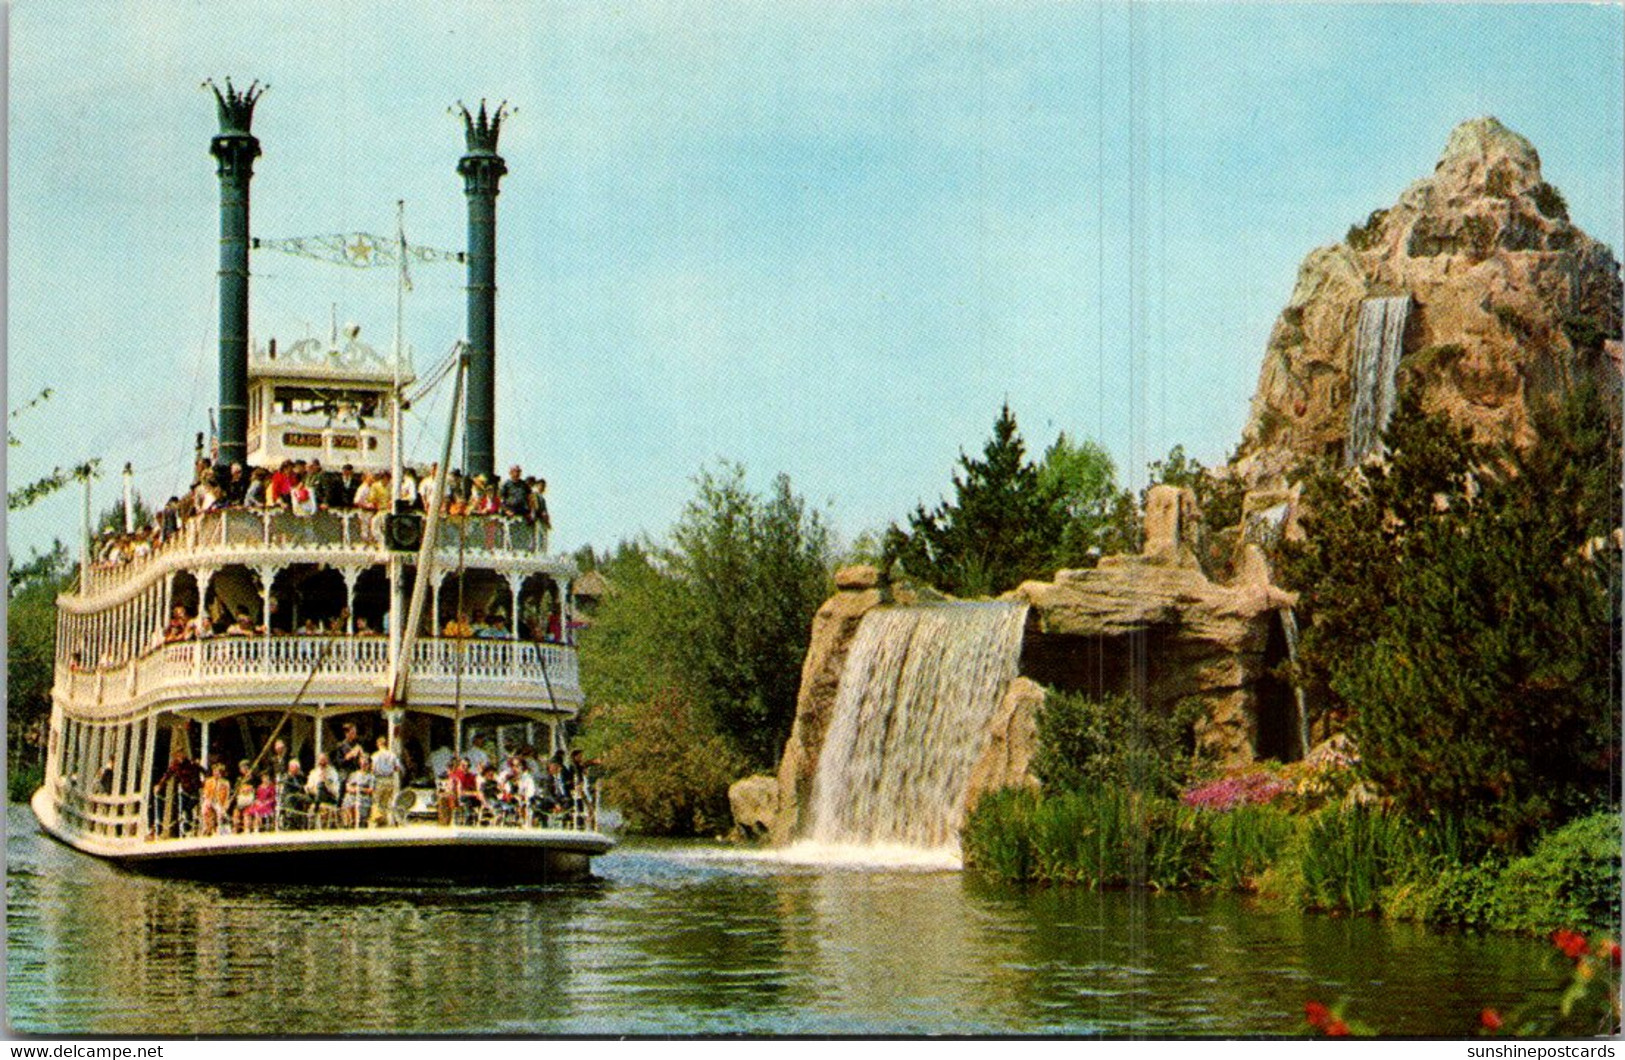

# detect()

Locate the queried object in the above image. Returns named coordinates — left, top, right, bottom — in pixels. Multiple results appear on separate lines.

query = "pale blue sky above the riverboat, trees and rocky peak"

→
left=7, top=0, right=1625, bottom=553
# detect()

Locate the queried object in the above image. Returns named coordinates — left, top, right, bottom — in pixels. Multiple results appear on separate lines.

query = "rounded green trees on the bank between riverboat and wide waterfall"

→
left=580, top=465, right=830, bottom=832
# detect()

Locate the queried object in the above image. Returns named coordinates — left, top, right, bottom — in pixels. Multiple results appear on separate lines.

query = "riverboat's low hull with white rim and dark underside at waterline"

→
left=33, top=788, right=614, bottom=884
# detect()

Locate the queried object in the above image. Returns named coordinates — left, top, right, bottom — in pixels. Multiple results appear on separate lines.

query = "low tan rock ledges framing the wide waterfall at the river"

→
left=767, top=486, right=1295, bottom=842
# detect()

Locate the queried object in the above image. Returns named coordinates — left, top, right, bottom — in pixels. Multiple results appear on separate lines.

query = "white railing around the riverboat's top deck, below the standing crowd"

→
left=86, top=507, right=548, bottom=593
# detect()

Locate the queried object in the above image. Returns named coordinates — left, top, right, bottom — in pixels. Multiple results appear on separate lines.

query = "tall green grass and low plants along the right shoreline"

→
left=962, top=785, right=1620, bottom=932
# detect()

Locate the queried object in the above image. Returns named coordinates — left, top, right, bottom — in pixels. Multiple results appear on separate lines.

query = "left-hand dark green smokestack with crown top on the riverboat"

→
left=206, top=78, right=265, bottom=463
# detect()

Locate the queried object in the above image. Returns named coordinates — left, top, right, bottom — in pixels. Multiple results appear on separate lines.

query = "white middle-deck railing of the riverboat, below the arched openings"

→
left=59, top=634, right=580, bottom=706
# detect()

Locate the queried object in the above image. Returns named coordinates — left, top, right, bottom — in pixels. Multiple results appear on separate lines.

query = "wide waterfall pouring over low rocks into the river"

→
left=811, top=603, right=1027, bottom=847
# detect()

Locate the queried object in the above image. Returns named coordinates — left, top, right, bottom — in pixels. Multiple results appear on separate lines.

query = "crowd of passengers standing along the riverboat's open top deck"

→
left=91, top=460, right=553, bottom=569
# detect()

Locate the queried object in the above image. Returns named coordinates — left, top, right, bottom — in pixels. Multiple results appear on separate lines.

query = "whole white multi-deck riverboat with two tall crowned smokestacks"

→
left=33, top=81, right=613, bottom=883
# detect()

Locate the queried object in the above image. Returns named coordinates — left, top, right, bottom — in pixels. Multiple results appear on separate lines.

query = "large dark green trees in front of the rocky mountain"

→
left=1284, top=392, right=1620, bottom=849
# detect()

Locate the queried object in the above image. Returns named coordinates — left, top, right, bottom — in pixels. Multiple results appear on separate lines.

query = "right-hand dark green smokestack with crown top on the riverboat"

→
left=457, top=99, right=509, bottom=478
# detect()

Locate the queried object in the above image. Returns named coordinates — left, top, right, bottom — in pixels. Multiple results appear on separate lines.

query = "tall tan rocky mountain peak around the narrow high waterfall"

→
left=1237, top=117, right=1622, bottom=484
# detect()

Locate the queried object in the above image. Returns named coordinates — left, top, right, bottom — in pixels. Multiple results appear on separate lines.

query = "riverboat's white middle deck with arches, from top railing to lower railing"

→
left=55, top=507, right=582, bottom=720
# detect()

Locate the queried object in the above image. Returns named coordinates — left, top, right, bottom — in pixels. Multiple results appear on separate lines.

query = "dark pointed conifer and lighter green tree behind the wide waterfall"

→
left=884, top=405, right=1134, bottom=597
